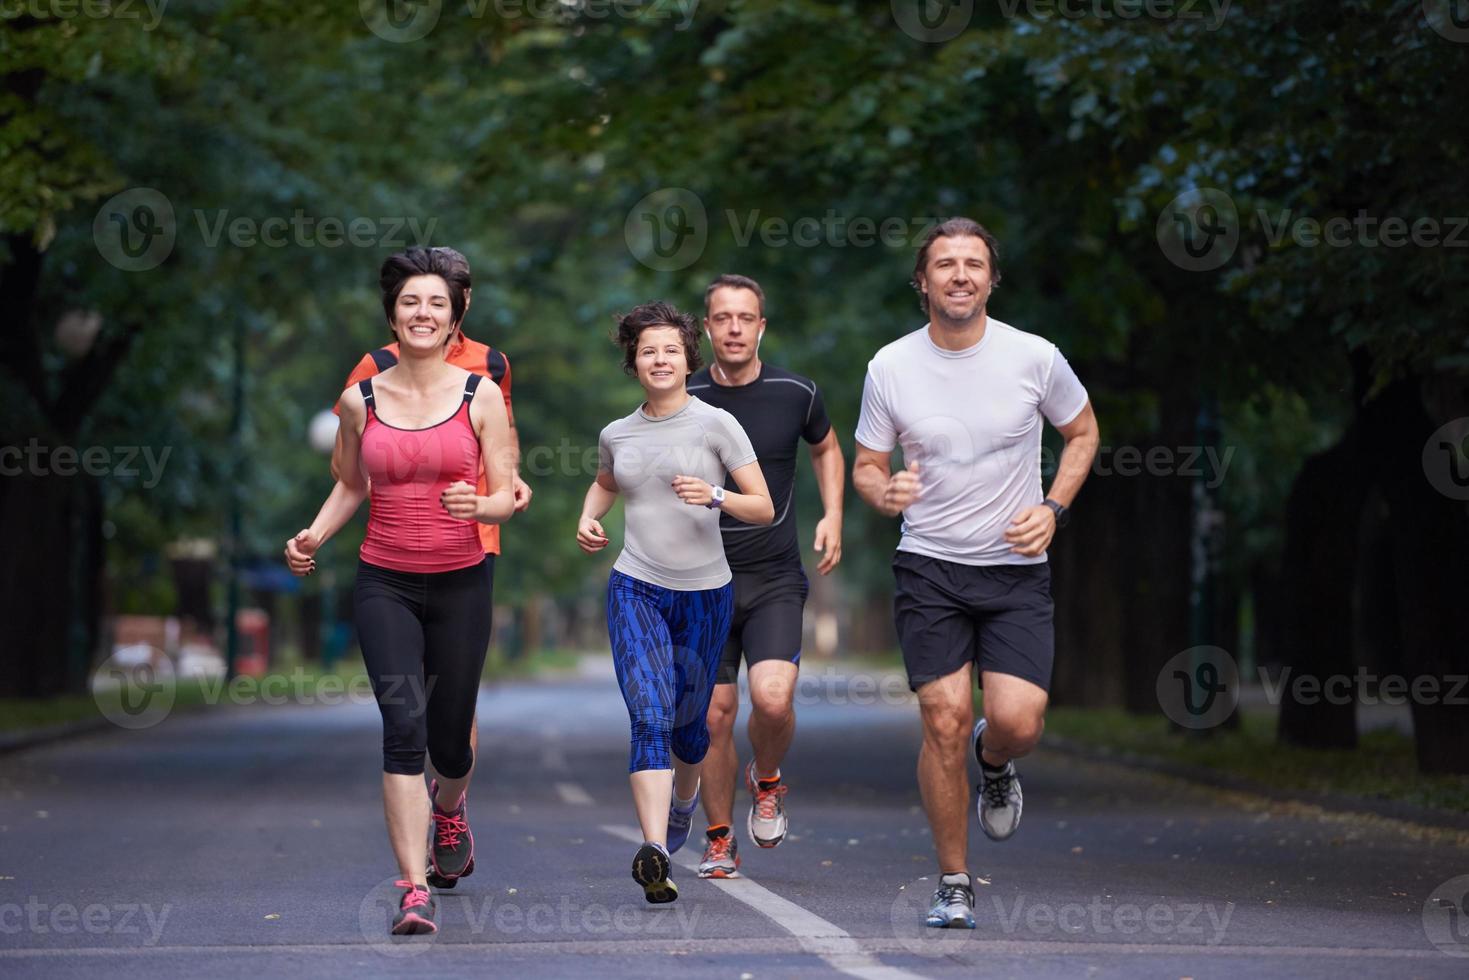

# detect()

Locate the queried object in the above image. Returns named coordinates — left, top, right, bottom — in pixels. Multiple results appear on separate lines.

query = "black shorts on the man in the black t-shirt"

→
left=715, top=563, right=809, bottom=685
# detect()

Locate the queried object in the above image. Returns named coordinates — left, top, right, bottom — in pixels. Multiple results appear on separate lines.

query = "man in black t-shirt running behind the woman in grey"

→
left=687, top=275, right=846, bottom=877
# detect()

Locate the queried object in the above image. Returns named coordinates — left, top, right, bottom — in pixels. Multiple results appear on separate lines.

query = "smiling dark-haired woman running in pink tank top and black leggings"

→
left=286, top=248, right=514, bottom=934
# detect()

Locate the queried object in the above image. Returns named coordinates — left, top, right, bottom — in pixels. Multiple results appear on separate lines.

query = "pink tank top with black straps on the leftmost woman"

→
left=357, top=375, right=485, bottom=573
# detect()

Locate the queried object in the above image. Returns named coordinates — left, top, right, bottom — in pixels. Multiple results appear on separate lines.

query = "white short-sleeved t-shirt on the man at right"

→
left=856, top=317, right=1087, bottom=564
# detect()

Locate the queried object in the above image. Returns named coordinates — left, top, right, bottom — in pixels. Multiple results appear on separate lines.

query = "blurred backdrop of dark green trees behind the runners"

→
left=0, top=0, right=1469, bottom=805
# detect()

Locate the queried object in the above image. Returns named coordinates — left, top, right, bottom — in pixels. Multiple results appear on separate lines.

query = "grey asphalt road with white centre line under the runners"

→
left=0, top=666, right=1469, bottom=980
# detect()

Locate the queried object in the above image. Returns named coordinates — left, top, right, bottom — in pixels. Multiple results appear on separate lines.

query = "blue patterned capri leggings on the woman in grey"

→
left=607, top=572, right=735, bottom=773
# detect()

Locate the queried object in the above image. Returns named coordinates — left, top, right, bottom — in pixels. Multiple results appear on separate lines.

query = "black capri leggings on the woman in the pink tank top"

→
left=353, top=555, right=495, bottom=779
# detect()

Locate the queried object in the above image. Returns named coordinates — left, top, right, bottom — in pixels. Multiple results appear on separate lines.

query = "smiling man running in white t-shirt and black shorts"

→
left=852, top=217, right=1097, bottom=929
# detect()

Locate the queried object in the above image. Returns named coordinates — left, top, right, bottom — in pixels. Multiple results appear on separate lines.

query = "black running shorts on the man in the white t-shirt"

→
left=893, top=551, right=1056, bottom=691
